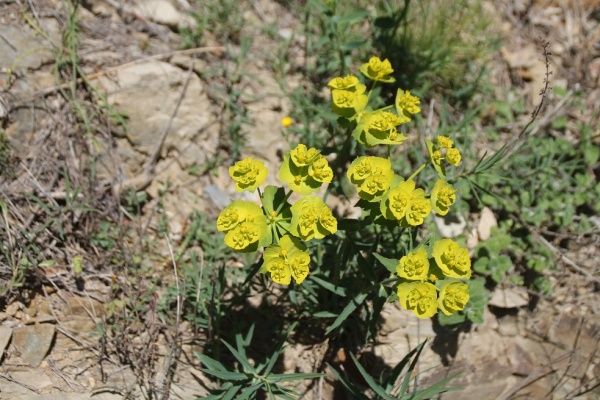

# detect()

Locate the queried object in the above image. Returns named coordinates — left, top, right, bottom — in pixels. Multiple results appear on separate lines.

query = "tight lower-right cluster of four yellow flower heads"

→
left=396, top=239, right=471, bottom=318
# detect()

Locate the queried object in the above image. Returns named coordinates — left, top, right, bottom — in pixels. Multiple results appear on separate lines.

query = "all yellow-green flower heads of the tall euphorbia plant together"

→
left=217, top=57, right=471, bottom=318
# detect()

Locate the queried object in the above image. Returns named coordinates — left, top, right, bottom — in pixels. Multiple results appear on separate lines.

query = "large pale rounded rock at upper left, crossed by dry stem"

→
left=97, top=61, right=218, bottom=168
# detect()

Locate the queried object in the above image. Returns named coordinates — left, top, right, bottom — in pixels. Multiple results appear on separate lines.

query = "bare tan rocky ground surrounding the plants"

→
left=0, top=0, right=600, bottom=400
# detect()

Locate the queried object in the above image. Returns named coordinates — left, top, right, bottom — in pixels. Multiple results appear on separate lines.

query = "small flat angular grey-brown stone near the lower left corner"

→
left=12, top=324, right=56, bottom=367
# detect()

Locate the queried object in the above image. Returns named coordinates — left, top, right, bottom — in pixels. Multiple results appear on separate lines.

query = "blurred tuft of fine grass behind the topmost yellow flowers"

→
left=372, top=0, right=499, bottom=105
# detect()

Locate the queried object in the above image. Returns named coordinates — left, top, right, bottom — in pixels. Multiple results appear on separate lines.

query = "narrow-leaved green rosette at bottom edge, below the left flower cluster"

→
left=195, top=325, right=325, bottom=400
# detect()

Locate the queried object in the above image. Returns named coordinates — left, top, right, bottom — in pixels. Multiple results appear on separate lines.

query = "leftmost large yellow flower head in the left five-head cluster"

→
left=217, top=200, right=268, bottom=252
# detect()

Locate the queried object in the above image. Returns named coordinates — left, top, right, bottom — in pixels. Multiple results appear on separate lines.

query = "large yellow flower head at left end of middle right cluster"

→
left=346, top=156, right=394, bottom=201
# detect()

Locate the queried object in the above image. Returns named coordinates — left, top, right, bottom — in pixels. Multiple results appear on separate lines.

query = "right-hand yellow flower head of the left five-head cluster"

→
left=289, top=195, right=337, bottom=241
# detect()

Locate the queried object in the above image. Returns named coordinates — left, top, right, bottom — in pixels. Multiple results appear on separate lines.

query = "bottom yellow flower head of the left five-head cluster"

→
left=260, top=235, right=310, bottom=285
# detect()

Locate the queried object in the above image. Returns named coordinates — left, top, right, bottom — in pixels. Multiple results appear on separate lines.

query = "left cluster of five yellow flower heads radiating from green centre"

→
left=217, top=144, right=337, bottom=285
